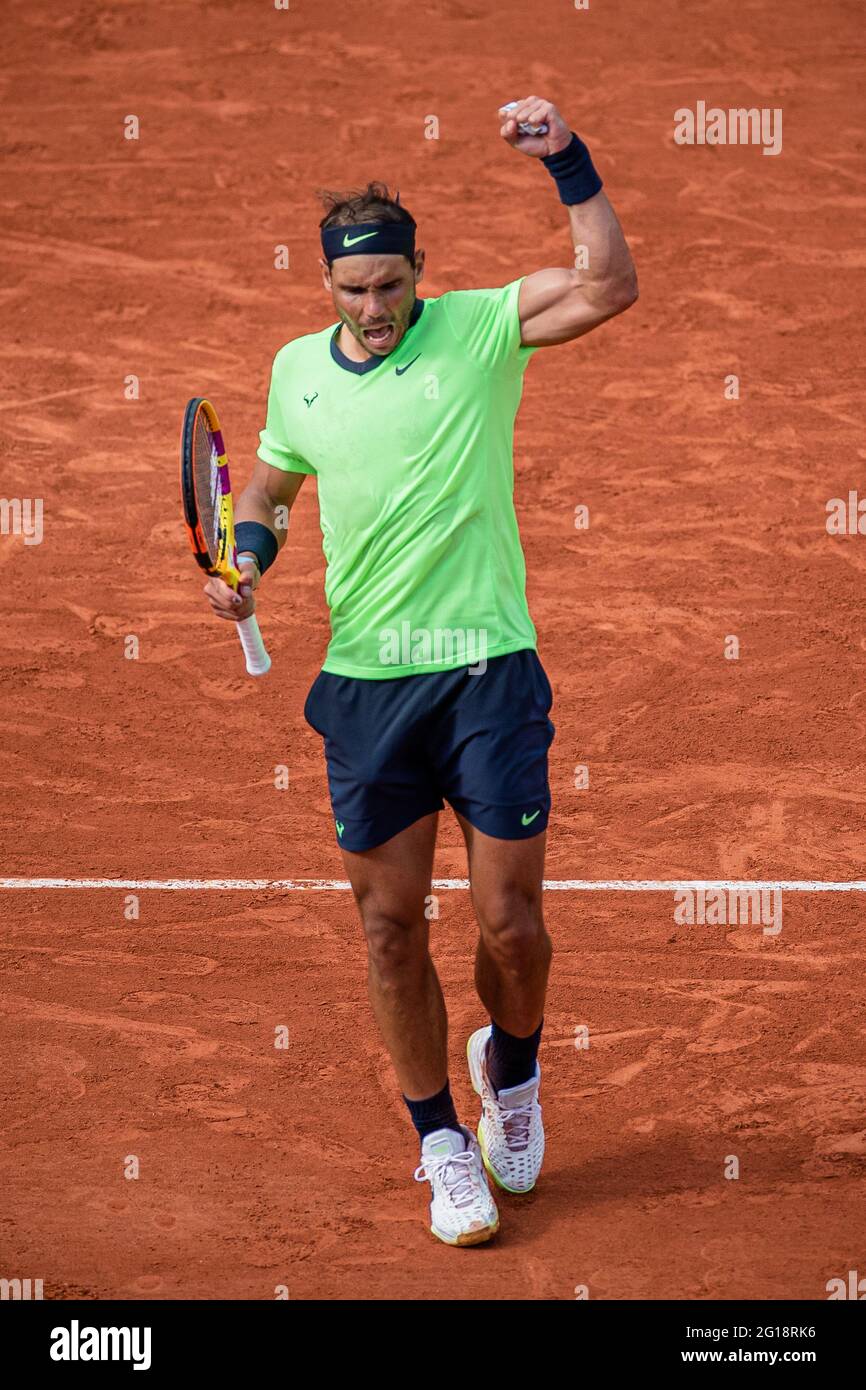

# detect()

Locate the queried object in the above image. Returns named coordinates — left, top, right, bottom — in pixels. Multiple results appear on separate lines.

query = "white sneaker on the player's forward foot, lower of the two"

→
left=414, top=1126, right=499, bottom=1245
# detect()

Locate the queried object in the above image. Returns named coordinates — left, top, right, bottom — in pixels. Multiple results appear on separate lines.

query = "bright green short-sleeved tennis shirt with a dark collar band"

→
left=259, top=279, right=537, bottom=680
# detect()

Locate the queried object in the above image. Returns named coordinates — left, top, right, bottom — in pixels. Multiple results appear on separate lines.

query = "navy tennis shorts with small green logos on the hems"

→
left=304, top=649, right=555, bottom=852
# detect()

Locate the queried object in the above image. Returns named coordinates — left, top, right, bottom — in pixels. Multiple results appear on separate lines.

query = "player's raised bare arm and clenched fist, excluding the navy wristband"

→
left=500, top=97, right=638, bottom=348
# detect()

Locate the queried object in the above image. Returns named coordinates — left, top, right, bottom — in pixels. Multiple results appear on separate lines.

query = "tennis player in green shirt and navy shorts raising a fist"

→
left=206, top=96, right=637, bottom=1245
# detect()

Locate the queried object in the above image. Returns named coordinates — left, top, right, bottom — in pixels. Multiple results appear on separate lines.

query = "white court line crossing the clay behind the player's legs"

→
left=0, top=878, right=866, bottom=892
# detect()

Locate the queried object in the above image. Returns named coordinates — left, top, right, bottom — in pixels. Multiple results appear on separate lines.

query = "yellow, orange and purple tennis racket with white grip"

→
left=181, top=396, right=271, bottom=676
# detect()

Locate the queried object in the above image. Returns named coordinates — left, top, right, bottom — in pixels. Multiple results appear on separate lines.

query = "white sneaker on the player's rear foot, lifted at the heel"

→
left=466, top=1024, right=545, bottom=1193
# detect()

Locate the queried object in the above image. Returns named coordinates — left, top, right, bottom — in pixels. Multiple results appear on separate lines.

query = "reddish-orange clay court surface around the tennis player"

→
left=0, top=0, right=866, bottom=1300
